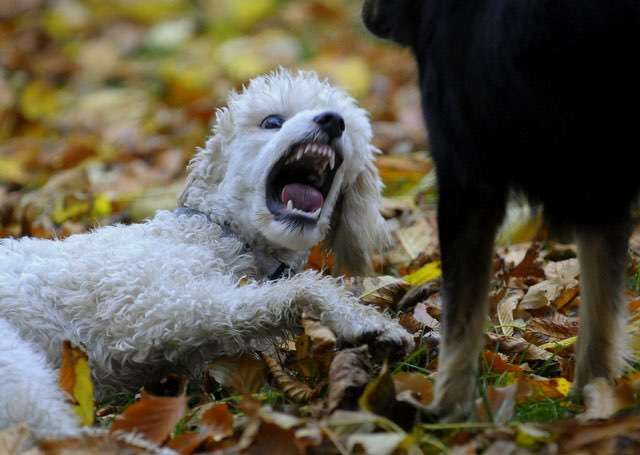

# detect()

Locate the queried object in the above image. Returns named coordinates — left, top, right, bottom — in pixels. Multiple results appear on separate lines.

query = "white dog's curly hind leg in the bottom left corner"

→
left=0, top=319, right=79, bottom=437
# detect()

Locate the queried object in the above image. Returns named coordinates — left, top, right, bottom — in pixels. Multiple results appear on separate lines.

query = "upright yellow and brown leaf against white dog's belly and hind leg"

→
left=60, top=341, right=94, bottom=426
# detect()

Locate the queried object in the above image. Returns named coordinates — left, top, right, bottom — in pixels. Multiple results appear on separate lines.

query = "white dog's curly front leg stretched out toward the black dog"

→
left=100, top=272, right=413, bottom=361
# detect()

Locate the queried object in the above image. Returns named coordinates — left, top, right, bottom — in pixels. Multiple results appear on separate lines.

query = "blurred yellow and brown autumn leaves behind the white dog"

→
left=0, top=0, right=431, bottom=238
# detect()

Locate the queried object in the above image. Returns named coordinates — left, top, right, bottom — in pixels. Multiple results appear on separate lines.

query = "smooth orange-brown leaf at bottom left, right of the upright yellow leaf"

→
left=110, top=395, right=187, bottom=444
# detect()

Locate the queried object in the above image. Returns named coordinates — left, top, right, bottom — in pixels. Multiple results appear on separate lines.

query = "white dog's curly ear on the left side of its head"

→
left=178, top=108, right=231, bottom=208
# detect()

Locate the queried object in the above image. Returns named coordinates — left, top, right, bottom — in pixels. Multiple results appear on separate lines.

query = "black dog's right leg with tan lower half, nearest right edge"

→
left=575, top=223, right=629, bottom=394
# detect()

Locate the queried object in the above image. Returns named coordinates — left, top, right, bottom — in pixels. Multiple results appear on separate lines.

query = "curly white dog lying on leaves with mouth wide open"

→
left=0, top=70, right=413, bottom=436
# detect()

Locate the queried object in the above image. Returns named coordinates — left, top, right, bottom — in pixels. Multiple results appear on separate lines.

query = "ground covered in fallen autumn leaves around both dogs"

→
left=0, top=0, right=640, bottom=454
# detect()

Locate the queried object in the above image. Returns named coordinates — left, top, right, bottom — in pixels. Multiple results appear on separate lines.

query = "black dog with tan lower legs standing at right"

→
left=363, top=0, right=640, bottom=418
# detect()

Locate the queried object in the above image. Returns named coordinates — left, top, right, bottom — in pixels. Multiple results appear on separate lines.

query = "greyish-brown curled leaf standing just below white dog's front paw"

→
left=328, top=346, right=371, bottom=412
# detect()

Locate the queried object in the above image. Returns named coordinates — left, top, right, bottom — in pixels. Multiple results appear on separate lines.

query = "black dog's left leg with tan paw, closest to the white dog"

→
left=431, top=178, right=505, bottom=420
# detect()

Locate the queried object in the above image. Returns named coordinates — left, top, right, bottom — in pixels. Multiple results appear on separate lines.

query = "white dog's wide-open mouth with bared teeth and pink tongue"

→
left=267, top=142, right=342, bottom=222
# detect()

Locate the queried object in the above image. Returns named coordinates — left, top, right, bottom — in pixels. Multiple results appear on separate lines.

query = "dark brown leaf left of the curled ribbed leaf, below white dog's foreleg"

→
left=208, top=355, right=266, bottom=394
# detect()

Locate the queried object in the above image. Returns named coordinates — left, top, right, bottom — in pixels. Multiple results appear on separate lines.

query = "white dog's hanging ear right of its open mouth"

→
left=327, top=151, right=389, bottom=276
